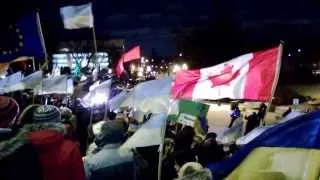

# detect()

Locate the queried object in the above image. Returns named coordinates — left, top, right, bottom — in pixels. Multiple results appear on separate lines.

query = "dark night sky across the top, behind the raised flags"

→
left=3, top=0, right=320, bottom=55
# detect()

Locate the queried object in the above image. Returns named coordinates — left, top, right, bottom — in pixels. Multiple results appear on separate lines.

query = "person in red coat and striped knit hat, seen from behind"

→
left=23, top=105, right=85, bottom=180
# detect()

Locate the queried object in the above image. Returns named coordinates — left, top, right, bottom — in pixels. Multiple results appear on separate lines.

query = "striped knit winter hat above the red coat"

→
left=33, top=105, right=61, bottom=123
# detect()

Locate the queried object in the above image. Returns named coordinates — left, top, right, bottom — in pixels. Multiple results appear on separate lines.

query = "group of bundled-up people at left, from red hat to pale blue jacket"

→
left=0, top=93, right=137, bottom=180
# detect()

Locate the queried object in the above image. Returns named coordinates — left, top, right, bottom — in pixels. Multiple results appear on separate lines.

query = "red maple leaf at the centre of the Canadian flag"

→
left=208, top=64, right=240, bottom=87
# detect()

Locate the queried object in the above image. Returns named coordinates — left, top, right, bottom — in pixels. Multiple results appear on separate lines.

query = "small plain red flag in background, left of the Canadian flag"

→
left=116, top=46, right=141, bottom=77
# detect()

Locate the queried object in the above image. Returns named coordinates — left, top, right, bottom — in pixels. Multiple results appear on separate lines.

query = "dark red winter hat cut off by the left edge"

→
left=0, top=96, right=19, bottom=128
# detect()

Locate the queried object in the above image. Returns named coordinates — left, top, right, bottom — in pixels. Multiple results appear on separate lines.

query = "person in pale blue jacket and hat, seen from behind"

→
left=83, top=120, right=136, bottom=180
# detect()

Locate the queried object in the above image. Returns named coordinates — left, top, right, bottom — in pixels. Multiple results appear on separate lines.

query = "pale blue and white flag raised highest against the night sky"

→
left=60, top=2, right=93, bottom=29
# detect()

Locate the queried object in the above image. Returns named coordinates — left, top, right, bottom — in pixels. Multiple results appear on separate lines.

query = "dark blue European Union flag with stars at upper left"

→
left=0, top=12, right=45, bottom=63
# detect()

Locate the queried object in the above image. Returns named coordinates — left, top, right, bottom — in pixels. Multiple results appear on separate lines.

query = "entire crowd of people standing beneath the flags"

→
left=0, top=79, right=286, bottom=180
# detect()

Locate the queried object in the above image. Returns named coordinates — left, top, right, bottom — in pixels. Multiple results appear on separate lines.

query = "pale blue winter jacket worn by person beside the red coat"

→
left=84, top=144, right=136, bottom=180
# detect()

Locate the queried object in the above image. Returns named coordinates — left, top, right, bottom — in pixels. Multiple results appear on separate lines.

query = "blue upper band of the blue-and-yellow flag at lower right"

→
left=208, top=110, right=320, bottom=179
